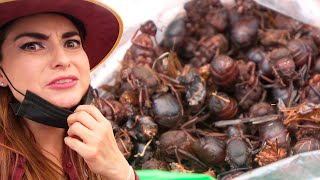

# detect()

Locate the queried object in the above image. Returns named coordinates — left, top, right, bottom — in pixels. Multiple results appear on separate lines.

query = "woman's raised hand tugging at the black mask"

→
left=65, top=105, right=130, bottom=179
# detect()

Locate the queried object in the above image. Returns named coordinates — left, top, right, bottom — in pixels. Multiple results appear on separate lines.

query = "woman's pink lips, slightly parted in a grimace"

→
left=48, top=76, right=78, bottom=89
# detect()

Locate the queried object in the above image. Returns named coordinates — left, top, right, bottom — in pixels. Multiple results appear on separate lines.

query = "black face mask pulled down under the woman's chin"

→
left=10, top=88, right=93, bottom=129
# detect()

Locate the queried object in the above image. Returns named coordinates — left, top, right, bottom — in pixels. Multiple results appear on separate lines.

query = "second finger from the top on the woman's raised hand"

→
left=67, top=111, right=99, bottom=130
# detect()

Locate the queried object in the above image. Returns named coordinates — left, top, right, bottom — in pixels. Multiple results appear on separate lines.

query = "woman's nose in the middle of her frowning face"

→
left=52, top=47, right=72, bottom=69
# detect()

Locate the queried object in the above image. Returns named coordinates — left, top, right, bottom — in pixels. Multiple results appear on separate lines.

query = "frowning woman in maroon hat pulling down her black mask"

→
left=0, top=0, right=138, bottom=180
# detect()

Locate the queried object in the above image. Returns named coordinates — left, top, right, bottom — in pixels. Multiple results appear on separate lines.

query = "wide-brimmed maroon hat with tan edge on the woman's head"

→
left=0, top=0, right=123, bottom=70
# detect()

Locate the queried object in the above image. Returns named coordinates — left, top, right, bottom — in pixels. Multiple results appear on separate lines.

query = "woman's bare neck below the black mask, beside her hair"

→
left=25, top=120, right=65, bottom=166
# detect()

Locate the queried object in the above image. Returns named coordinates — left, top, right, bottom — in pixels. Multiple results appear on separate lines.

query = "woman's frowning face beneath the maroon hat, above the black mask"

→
left=0, top=14, right=90, bottom=108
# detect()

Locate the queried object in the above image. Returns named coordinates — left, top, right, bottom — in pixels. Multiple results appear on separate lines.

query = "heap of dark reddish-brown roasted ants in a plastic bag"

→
left=112, top=0, right=320, bottom=176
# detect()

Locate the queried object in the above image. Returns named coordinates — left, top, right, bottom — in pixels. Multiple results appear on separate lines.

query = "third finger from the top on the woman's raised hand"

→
left=67, top=122, right=96, bottom=144
